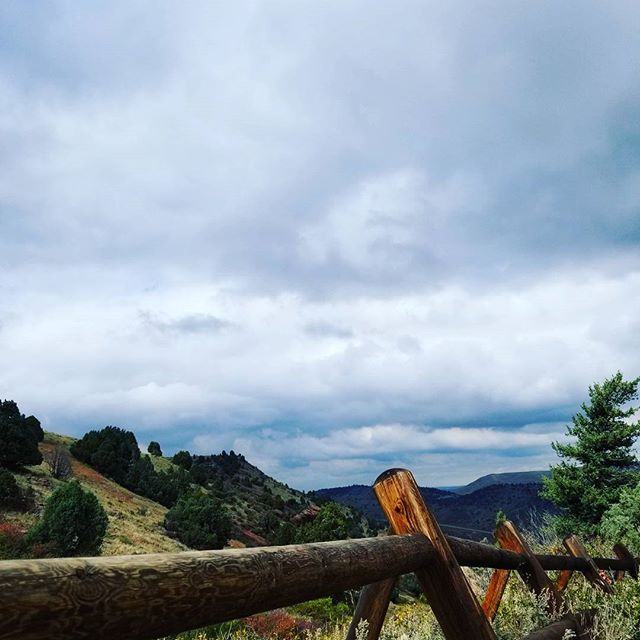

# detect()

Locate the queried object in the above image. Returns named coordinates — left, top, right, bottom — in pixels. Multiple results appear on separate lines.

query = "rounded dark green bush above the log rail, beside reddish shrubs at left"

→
left=27, top=480, right=107, bottom=556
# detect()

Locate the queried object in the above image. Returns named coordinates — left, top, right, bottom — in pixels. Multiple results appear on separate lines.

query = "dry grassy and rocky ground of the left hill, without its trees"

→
left=0, top=433, right=369, bottom=555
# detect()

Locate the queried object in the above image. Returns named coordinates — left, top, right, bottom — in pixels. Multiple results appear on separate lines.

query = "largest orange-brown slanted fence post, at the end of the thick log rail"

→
left=373, top=469, right=496, bottom=640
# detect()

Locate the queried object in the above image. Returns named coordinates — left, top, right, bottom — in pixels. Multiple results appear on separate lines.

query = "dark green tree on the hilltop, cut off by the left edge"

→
left=0, top=400, right=44, bottom=469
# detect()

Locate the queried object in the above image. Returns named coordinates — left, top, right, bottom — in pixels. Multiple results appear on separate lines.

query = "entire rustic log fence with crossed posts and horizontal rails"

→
left=0, top=469, right=638, bottom=640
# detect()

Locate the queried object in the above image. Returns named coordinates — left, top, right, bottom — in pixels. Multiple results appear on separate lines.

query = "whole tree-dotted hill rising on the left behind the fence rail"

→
left=0, top=401, right=370, bottom=557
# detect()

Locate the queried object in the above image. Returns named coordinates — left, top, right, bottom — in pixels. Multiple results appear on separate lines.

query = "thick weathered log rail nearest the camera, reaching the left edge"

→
left=0, top=534, right=435, bottom=640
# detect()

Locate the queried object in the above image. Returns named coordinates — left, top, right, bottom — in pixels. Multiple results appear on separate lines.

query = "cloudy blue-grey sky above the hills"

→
left=0, top=0, right=640, bottom=489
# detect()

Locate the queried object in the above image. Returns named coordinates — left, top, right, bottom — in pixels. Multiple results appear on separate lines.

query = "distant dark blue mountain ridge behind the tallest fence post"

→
left=315, top=482, right=557, bottom=540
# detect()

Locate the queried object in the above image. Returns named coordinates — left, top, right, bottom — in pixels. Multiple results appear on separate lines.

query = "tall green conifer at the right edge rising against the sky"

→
left=542, top=372, right=640, bottom=533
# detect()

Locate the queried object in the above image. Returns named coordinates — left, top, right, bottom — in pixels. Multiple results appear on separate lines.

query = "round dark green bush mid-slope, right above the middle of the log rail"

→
left=165, top=491, right=231, bottom=549
